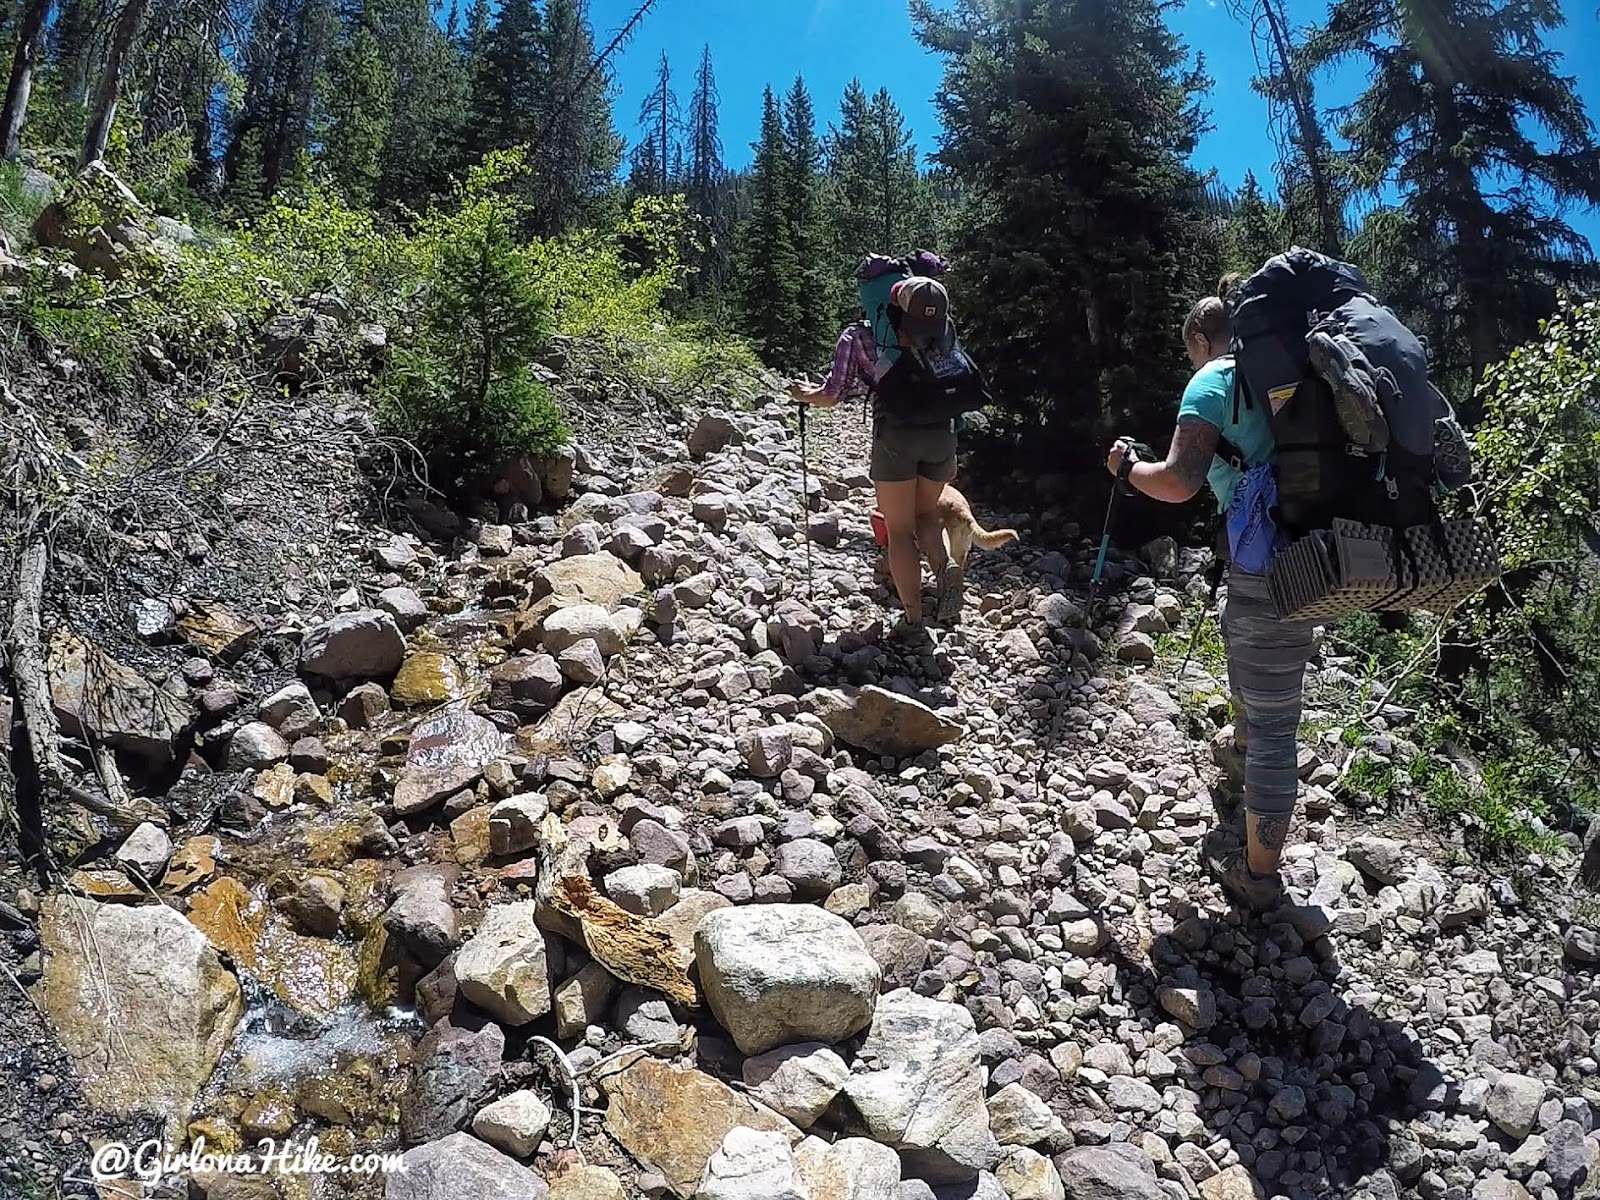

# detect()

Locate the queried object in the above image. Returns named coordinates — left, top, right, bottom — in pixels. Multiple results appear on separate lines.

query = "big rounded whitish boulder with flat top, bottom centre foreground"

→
left=694, top=904, right=882, bottom=1054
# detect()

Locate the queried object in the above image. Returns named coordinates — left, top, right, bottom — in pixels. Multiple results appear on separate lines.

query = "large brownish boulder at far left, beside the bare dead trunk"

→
left=48, top=629, right=194, bottom=763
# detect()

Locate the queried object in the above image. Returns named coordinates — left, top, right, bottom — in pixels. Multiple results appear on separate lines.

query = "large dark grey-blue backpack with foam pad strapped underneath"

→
left=1229, top=246, right=1499, bottom=618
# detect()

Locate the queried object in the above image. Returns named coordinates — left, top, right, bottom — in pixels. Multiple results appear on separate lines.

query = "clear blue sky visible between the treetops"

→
left=590, top=0, right=1600, bottom=253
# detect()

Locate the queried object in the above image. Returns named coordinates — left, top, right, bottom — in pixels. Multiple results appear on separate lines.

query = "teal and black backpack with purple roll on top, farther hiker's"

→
left=856, top=250, right=990, bottom=426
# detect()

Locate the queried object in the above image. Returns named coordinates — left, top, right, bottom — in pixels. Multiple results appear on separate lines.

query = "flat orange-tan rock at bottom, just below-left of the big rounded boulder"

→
left=600, top=1058, right=800, bottom=1197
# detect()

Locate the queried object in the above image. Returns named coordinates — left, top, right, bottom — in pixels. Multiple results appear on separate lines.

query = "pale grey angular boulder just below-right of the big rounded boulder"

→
left=845, top=990, right=1000, bottom=1184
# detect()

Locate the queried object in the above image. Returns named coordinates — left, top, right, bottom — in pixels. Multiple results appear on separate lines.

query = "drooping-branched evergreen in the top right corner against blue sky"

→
left=1307, top=0, right=1600, bottom=381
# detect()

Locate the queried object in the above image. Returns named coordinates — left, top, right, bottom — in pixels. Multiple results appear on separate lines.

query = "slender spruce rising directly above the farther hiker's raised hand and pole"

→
left=782, top=75, right=835, bottom=365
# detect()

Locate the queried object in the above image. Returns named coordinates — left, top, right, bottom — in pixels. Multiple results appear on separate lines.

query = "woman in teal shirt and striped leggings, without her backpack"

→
left=1106, top=296, right=1310, bottom=910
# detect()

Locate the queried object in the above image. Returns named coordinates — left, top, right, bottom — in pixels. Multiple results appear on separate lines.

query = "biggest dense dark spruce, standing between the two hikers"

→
left=912, top=0, right=1218, bottom=467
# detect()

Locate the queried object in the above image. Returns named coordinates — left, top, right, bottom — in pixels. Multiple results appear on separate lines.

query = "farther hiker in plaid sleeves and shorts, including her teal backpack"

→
left=789, top=251, right=989, bottom=642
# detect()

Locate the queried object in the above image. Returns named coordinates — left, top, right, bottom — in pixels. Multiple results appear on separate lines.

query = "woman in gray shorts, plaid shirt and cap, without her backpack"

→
left=789, top=275, right=963, bottom=638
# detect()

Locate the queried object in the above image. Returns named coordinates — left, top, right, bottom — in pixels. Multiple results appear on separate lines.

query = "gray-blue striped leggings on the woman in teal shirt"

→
left=1221, top=568, right=1312, bottom=816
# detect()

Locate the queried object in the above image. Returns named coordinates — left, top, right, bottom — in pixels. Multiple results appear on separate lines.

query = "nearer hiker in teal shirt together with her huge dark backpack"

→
left=1106, top=246, right=1499, bottom=910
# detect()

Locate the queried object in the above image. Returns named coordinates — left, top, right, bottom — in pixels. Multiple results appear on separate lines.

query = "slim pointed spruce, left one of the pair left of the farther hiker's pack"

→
left=738, top=88, right=802, bottom=368
